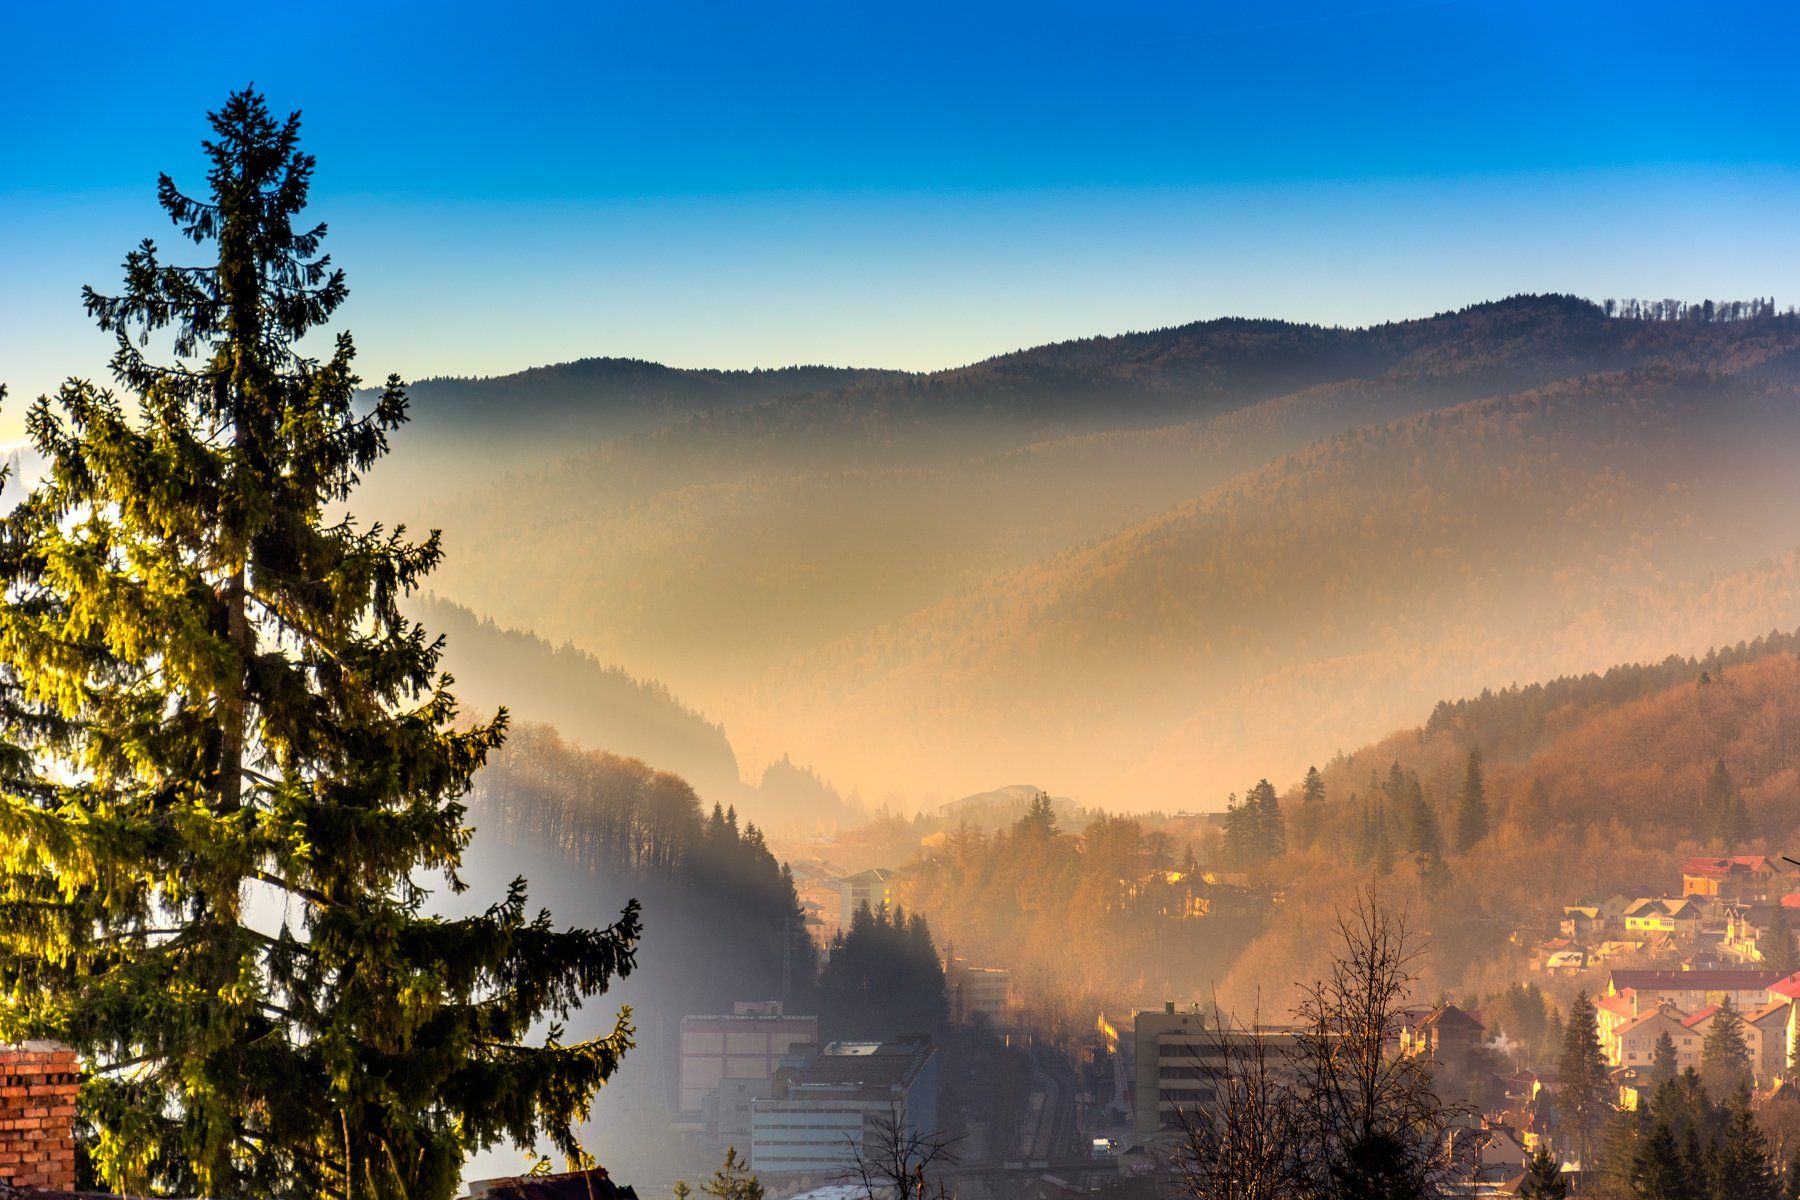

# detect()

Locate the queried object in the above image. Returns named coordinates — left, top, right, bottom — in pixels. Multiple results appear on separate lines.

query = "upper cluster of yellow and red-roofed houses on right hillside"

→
left=1534, top=855, right=1800, bottom=975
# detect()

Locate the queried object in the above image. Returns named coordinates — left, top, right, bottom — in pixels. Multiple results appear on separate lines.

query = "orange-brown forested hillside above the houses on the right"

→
left=1222, top=635, right=1800, bottom=1004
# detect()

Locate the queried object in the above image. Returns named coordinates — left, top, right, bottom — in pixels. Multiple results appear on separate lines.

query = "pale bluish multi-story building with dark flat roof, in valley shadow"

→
left=751, top=1038, right=941, bottom=1178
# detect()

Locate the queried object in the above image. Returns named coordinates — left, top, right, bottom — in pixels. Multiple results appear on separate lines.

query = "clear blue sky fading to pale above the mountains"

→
left=0, top=0, right=1800, bottom=424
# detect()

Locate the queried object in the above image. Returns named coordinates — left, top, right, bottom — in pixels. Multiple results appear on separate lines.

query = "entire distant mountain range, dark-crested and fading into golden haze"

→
left=373, top=297, right=1800, bottom=808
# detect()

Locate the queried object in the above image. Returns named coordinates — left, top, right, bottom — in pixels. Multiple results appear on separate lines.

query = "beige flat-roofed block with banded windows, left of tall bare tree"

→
left=1132, top=1004, right=1298, bottom=1141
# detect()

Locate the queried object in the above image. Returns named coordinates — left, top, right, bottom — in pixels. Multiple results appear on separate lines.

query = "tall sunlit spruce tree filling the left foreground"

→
left=0, top=90, right=637, bottom=1200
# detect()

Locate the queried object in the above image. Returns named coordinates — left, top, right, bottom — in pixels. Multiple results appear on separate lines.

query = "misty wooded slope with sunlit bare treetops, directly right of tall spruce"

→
left=441, top=725, right=815, bottom=1171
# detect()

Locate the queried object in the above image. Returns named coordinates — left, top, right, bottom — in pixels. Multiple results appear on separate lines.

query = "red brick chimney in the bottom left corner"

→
left=0, top=1042, right=81, bottom=1191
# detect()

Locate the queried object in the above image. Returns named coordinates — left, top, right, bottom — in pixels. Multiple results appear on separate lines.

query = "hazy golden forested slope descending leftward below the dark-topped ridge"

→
left=760, top=372, right=1800, bottom=808
